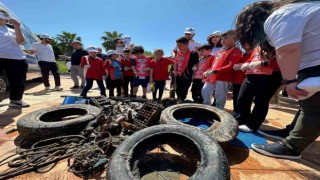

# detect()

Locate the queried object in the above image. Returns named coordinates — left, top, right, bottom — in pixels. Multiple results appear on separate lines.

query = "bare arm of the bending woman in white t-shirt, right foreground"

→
left=276, top=43, right=308, bottom=99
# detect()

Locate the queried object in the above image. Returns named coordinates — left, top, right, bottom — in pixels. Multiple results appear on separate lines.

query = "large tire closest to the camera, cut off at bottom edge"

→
left=107, top=125, right=230, bottom=180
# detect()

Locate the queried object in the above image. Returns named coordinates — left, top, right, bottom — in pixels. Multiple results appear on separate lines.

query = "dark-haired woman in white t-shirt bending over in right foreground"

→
left=236, top=0, right=320, bottom=159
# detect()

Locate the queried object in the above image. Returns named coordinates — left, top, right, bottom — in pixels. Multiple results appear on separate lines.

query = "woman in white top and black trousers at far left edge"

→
left=0, top=10, right=30, bottom=108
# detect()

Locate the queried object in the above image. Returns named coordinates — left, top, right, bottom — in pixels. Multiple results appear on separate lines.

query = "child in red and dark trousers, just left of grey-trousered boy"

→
left=191, top=44, right=213, bottom=103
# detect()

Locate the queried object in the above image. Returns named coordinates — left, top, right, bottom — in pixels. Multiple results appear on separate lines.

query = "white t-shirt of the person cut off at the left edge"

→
left=0, top=26, right=26, bottom=60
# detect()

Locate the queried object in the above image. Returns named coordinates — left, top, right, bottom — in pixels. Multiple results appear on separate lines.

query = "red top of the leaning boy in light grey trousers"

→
left=206, top=47, right=242, bottom=82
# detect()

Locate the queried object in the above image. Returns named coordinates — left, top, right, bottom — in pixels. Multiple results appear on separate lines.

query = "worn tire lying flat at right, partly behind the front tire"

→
left=160, top=104, right=239, bottom=142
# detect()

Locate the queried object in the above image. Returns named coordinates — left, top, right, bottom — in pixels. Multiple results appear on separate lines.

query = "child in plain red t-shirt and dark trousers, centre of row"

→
left=150, top=49, right=173, bottom=101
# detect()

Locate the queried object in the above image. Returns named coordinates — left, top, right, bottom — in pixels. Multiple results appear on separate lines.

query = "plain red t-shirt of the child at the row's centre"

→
left=150, top=58, right=174, bottom=81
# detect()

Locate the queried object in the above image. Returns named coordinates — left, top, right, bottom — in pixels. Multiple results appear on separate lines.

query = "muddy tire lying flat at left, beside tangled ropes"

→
left=17, top=104, right=101, bottom=139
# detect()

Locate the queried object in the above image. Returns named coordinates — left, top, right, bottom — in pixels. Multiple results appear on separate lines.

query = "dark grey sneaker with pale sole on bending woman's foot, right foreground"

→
left=251, top=142, right=301, bottom=159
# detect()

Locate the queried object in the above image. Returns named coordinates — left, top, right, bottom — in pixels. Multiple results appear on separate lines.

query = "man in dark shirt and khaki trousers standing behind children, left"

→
left=70, top=40, right=88, bottom=89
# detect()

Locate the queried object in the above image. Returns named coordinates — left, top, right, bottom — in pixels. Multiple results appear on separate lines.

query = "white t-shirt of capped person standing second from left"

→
left=32, top=42, right=56, bottom=62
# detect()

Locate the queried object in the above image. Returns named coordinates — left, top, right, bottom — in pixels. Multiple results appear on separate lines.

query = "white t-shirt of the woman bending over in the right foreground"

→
left=264, top=2, right=320, bottom=70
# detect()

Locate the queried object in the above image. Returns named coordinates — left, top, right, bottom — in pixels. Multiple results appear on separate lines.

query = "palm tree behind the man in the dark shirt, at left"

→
left=55, top=31, right=81, bottom=56
